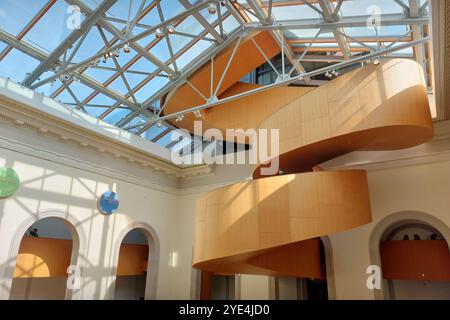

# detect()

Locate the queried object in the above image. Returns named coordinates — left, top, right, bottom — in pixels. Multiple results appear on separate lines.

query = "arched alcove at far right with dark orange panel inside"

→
left=369, top=212, right=450, bottom=299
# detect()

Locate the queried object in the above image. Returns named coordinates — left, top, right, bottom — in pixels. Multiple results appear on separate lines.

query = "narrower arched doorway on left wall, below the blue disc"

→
left=113, top=224, right=159, bottom=300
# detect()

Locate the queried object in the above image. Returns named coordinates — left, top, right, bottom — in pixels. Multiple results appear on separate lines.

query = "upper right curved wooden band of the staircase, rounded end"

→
left=254, top=59, right=434, bottom=178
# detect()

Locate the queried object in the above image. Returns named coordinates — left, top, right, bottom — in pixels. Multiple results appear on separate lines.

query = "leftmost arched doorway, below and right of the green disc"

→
left=9, top=217, right=81, bottom=300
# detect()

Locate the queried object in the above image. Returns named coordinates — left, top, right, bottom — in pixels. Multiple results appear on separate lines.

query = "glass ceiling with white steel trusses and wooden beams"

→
left=0, top=0, right=431, bottom=152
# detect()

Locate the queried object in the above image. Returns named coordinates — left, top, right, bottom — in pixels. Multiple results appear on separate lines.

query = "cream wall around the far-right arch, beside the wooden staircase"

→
left=329, top=161, right=450, bottom=299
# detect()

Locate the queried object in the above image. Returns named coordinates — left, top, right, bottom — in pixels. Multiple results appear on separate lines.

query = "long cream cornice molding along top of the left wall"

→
left=0, top=78, right=212, bottom=179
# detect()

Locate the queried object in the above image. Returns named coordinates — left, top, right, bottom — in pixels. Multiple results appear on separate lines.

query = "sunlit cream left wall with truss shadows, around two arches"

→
left=0, top=122, right=179, bottom=299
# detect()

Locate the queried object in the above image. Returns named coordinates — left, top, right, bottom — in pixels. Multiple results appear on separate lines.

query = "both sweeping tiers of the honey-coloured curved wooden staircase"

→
left=184, top=60, right=433, bottom=278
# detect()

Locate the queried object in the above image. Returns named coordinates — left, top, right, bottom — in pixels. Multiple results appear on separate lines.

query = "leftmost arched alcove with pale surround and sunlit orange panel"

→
left=2, top=212, right=82, bottom=299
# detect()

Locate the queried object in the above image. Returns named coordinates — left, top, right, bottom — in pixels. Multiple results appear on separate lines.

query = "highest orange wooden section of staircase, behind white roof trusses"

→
left=161, top=32, right=290, bottom=132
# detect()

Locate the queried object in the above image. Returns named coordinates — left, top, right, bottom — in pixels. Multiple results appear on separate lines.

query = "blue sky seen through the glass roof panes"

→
left=0, top=0, right=432, bottom=150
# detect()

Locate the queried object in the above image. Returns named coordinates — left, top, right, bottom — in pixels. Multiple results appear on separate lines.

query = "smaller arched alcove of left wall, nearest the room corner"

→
left=108, top=223, right=159, bottom=300
